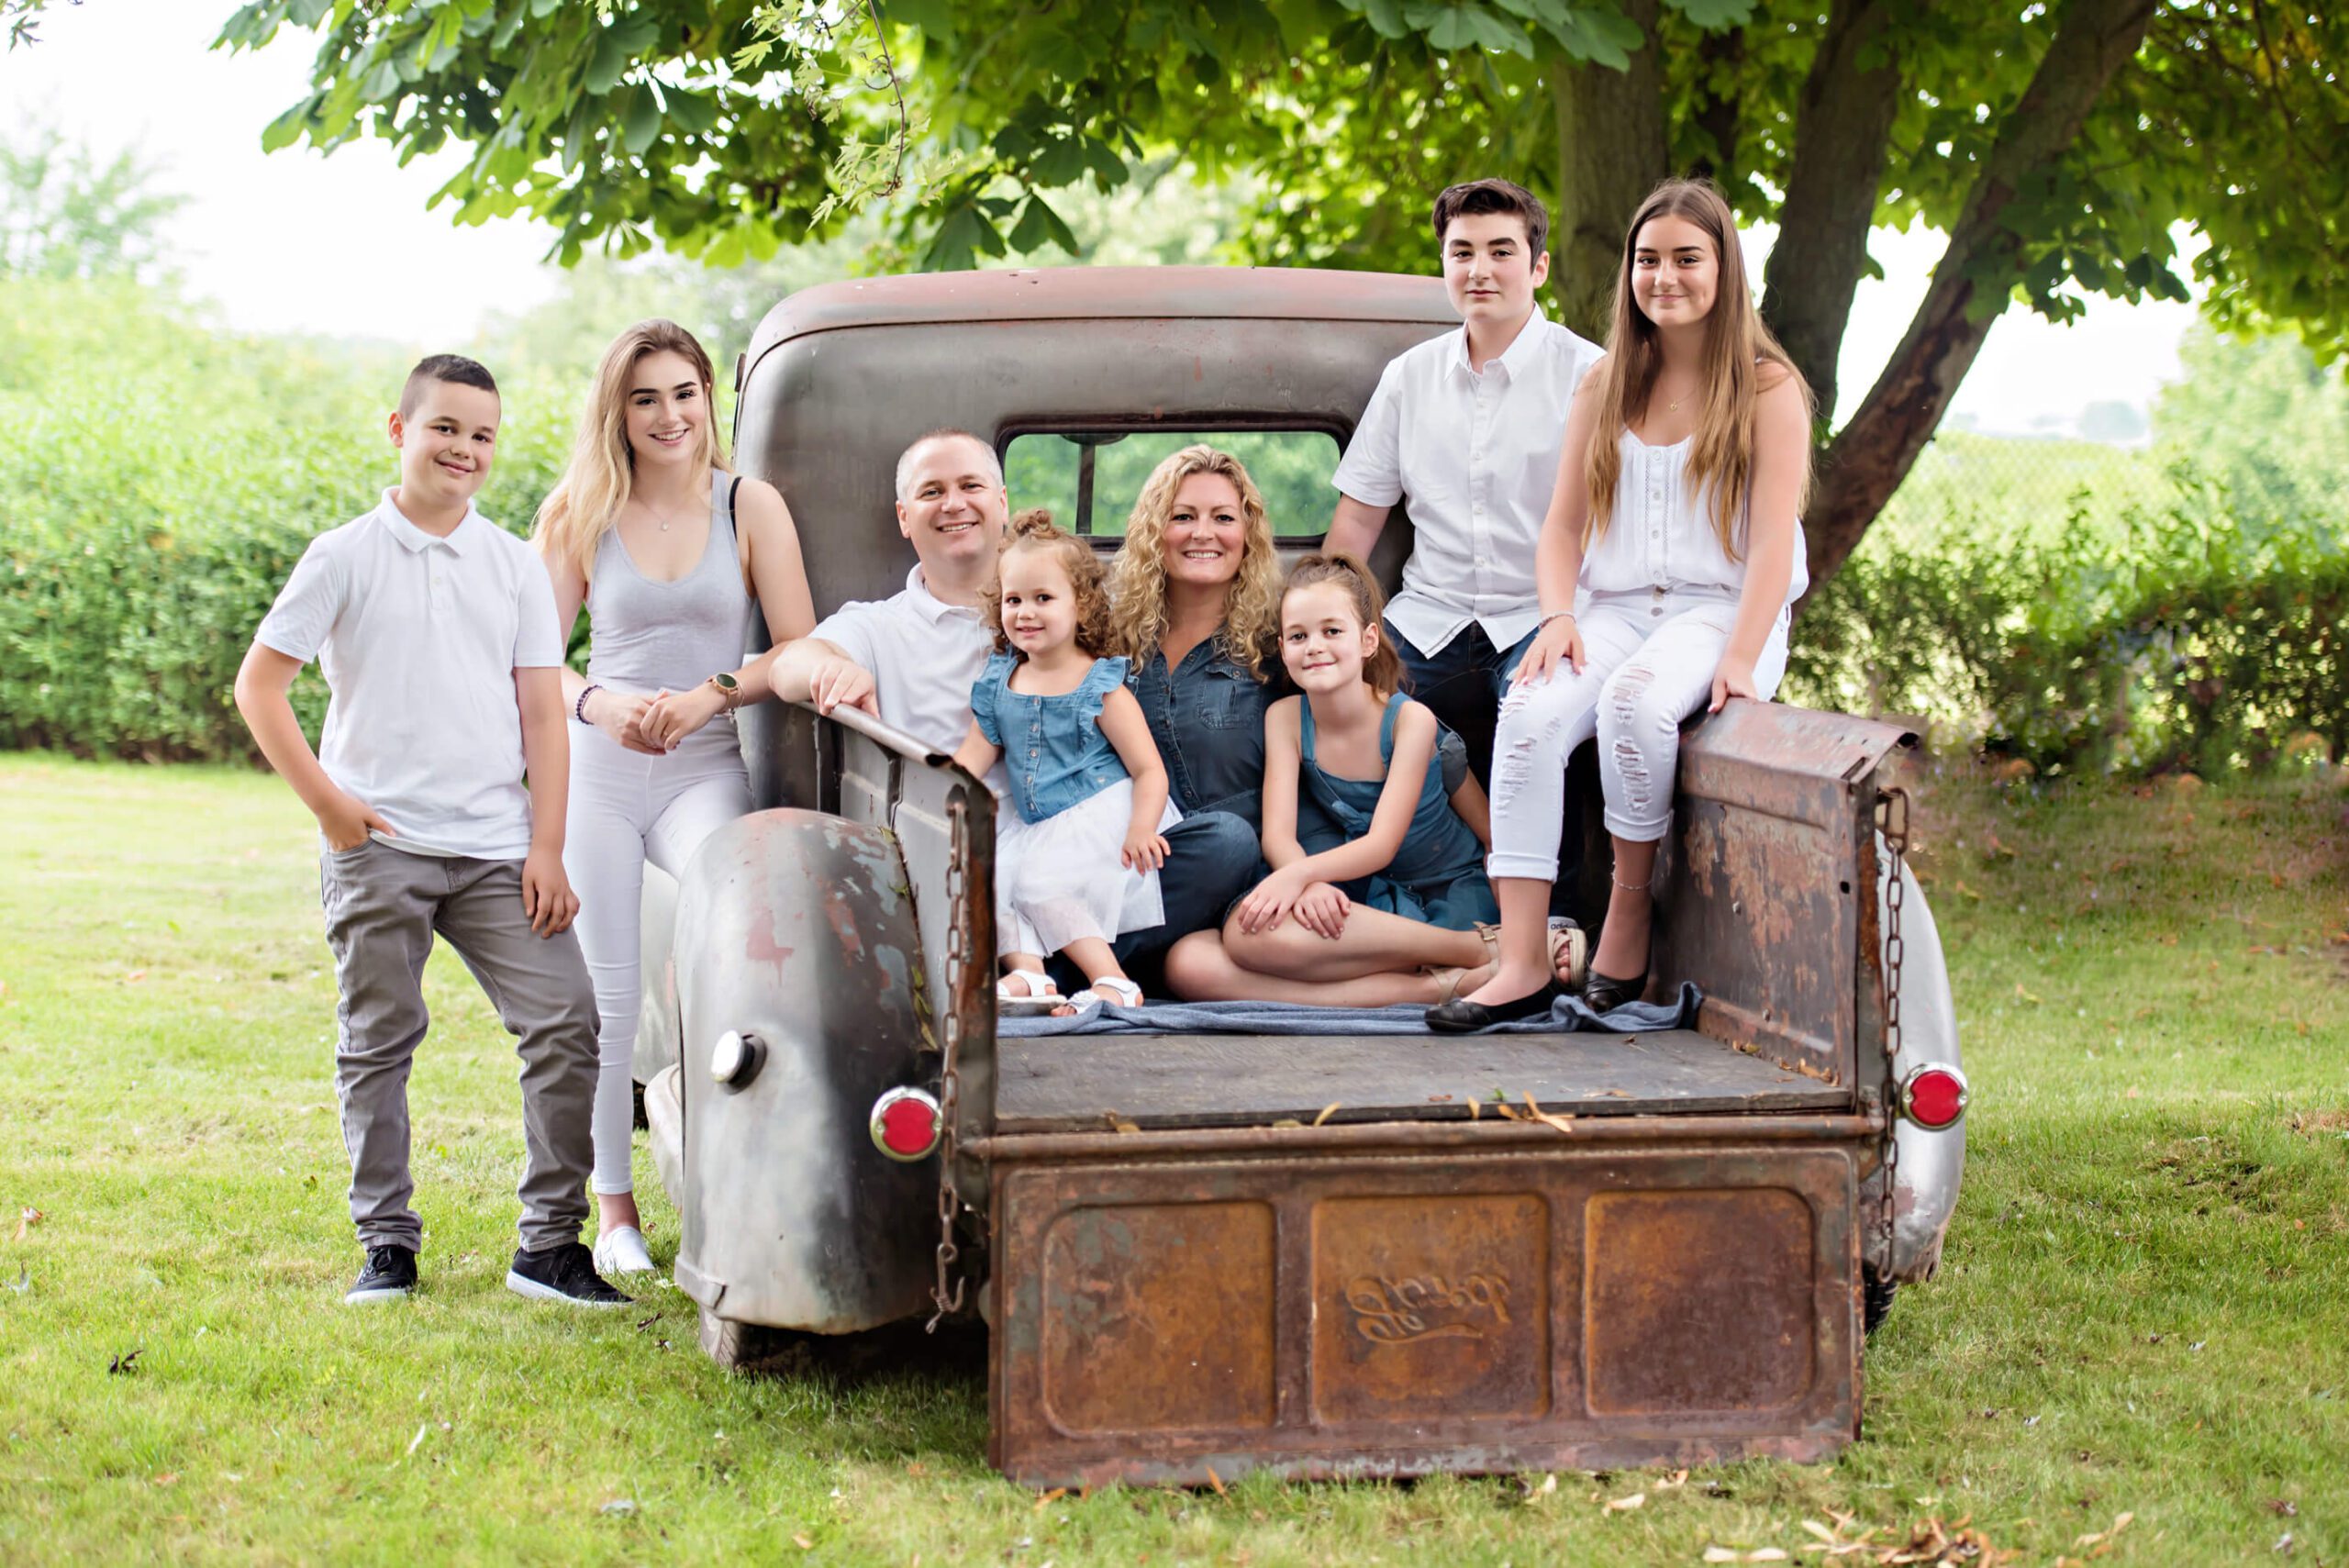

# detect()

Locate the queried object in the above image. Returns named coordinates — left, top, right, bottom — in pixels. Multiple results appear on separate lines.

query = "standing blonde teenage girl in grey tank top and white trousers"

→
left=533, top=321, right=815, bottom=1274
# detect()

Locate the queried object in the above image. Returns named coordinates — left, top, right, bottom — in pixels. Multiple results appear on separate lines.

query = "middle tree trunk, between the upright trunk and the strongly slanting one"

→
left=1762, top=0, right=1900, bottom=420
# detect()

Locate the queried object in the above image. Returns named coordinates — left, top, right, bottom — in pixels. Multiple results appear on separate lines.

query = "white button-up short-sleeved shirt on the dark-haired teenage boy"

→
left=1332, top=307, right=1604, bottom=655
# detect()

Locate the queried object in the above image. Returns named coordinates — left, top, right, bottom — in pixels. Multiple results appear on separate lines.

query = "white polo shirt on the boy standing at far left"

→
left=256, top=491, right=563, bottom=859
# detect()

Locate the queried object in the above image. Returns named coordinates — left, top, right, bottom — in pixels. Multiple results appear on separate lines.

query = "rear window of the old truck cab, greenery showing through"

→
left=1003, top=429, right=1339, bottom=545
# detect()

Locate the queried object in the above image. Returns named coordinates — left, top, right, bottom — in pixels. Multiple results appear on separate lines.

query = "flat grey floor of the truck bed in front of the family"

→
left=996, top=1029, right=1851, bottom=1134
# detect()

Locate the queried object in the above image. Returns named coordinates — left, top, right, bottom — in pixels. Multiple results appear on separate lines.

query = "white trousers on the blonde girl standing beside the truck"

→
left=563, top=718, right=750, bottom=1195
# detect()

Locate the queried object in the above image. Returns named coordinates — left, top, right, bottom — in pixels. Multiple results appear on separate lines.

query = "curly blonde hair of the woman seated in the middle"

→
left=1108, top=446, right=1280, bottom=681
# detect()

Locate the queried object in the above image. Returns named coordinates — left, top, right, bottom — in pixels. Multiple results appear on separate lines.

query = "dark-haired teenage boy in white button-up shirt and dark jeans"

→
left=1322, top=181, right=1599, bottom=788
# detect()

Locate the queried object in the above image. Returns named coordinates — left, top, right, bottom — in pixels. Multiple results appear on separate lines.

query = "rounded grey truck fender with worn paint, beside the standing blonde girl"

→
left=646, top=810, right=937, bottom=1333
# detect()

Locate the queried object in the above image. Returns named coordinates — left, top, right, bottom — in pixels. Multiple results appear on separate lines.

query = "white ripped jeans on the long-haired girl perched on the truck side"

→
left=1485, top=589, right=1787, bottom=883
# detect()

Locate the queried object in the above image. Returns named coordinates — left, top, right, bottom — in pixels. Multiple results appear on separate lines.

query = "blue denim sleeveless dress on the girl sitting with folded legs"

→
left=1297, top=693, right=1501, bottom=932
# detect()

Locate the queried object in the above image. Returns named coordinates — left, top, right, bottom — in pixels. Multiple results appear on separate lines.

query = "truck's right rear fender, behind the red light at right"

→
left=1861, top=836, right=1966, bottom=1279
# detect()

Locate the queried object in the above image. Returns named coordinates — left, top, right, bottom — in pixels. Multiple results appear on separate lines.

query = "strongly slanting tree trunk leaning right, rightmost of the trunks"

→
left=1804, top=0, right=2154, bottom=587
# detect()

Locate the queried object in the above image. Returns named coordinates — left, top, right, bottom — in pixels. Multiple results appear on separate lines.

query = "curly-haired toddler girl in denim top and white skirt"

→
left=953, top=509, right=1182, bottom=1012
